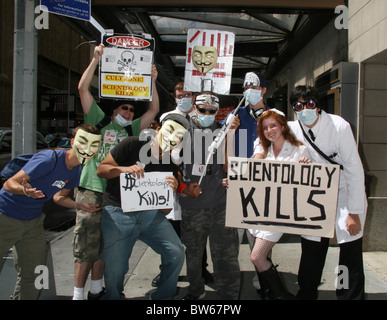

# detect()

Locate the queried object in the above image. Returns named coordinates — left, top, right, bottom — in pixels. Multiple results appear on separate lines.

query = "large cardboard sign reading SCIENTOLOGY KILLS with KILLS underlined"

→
left=226, top=157, right=340, bottom=238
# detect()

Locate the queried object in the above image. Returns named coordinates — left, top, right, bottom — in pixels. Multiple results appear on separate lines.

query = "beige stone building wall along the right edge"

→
left=348, top=0, right=387, bottom=251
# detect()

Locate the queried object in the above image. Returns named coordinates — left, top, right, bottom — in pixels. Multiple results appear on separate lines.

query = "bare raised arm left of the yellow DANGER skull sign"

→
left=78, top=44, right=105, bottom=115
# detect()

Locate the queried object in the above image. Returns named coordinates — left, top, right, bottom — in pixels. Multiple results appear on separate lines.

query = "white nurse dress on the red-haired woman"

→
left=249, top=140, right=311, bottom=242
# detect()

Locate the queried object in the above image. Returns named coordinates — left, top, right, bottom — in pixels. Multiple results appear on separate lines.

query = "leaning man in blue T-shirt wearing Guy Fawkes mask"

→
left=0, top=124, right=101, bottom=300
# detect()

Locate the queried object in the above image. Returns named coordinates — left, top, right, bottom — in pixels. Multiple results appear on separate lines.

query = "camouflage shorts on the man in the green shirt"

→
left=73, top=188, right=103, bottom=262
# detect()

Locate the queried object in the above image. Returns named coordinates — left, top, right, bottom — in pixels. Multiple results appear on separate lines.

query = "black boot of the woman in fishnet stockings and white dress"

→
left=259, top=265, right=295, bottom=300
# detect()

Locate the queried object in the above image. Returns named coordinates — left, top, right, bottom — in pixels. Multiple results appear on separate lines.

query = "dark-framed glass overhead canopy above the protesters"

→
left=65, top=0, right=344, bottom=94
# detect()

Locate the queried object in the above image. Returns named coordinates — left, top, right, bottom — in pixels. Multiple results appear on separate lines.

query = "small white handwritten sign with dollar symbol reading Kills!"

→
left=120, top=172, right=174, bottom=212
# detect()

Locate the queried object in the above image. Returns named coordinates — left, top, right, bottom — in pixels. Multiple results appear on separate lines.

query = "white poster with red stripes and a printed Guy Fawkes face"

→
left=184, top=29, right=235, bottom=95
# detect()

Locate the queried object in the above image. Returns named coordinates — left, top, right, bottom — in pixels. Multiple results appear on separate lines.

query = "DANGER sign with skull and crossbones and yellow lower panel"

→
left=99, top=34, right=154, bottom=101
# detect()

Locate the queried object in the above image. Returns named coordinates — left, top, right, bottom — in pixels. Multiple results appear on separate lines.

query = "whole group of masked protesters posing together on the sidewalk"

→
left=0, top=44, right=367, bottom=300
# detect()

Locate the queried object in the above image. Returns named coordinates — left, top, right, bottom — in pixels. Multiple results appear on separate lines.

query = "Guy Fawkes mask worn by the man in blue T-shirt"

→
left=72, top=129, right=101, bottom=165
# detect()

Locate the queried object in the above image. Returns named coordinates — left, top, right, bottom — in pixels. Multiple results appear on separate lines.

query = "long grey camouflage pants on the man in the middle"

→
left=181, top=205, right=241, bottom=300
